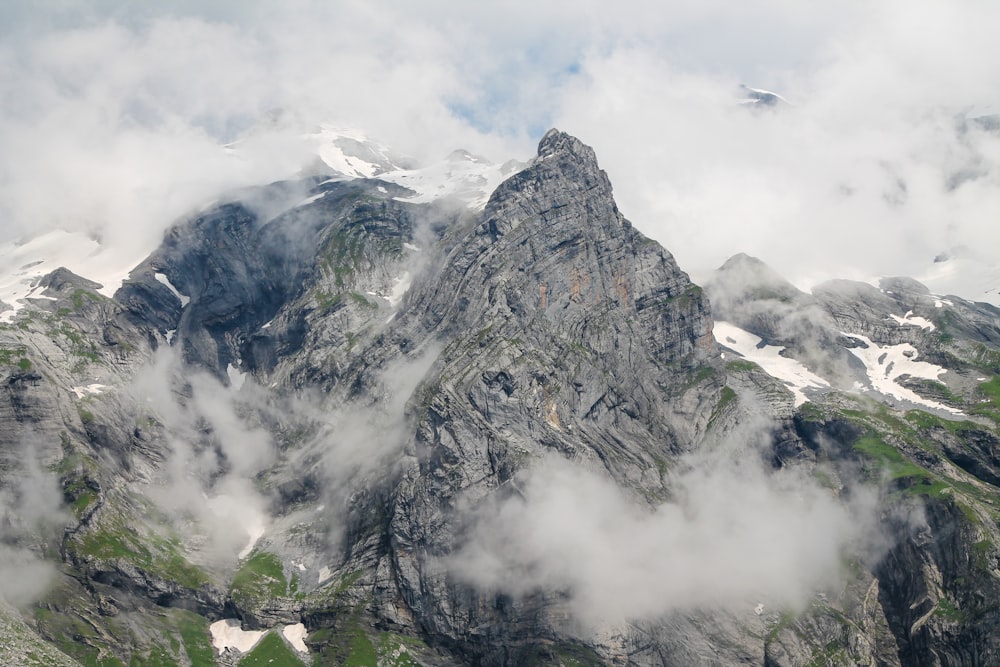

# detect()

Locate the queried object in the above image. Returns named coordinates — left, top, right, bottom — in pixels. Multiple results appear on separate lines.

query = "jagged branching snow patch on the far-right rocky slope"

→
left=841, top=332, right=962, bottom=415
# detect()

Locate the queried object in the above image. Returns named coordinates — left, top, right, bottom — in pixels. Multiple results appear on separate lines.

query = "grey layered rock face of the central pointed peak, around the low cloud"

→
left=382, top=131, right=721, bottom=664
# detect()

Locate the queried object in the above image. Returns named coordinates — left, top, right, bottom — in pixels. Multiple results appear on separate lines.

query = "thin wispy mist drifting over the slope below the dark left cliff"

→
left=126, top=345, right=440, bottom=572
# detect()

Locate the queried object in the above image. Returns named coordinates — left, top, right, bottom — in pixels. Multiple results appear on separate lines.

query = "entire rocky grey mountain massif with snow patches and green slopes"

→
left=0, top=130, right=1000, bottom=665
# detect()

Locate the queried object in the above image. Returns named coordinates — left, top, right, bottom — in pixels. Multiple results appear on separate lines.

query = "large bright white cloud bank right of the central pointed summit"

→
left=554, top=2, right=1000, bottom=288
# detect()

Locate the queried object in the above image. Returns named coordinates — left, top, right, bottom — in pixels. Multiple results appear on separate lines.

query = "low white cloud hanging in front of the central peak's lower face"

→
left=447, top=414, right=878, bottom=628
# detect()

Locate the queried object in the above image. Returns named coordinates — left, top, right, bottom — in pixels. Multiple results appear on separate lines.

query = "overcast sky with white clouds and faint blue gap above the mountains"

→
left=0, top=0, right=1000, bottom=292
